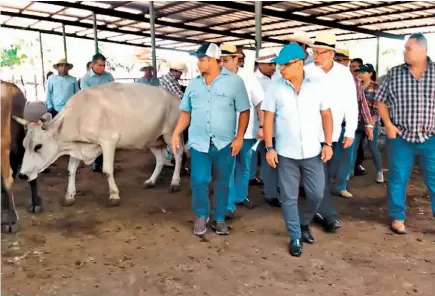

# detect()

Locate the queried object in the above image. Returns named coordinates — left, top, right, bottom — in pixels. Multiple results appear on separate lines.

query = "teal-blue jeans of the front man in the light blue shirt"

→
left=190, top=144, right=235, bottom=221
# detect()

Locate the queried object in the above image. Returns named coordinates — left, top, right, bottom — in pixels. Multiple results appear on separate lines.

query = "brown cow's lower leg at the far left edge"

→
left=1, top=176, right=18, bottom=233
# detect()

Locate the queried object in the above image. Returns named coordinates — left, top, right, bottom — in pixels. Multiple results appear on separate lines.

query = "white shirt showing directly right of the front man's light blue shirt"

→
left=237, top=67, right=264, bottom=139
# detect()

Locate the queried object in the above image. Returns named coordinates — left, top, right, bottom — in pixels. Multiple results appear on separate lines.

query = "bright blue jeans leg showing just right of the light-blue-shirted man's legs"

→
left=228, top=139, right=257, bottom=212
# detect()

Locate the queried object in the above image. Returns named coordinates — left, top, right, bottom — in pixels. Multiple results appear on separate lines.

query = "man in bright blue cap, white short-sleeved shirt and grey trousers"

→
left=262, top=43, right=333, bottom=257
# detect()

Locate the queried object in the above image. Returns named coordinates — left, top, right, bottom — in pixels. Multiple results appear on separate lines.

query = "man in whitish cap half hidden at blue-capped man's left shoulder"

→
left=251, top=48, right=281, bottom=207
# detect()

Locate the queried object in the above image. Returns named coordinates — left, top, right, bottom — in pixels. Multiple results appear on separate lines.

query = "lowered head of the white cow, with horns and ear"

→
left=14, top=113, right=60, bottom=181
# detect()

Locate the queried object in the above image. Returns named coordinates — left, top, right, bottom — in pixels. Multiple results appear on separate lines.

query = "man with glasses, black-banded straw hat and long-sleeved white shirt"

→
left=305, top=31, right=358, bottom=232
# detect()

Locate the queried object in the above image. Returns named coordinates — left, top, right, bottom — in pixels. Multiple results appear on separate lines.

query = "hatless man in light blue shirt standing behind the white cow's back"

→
left=80, top=53, right=114, bottom=172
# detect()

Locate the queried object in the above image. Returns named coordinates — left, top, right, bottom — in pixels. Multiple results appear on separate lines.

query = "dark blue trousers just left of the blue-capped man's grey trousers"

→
left=258, top=139, right=279, bottom=200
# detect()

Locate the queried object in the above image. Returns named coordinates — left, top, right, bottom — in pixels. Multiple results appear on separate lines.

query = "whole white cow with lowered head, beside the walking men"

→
left=15, top=83, right=183, bottom=205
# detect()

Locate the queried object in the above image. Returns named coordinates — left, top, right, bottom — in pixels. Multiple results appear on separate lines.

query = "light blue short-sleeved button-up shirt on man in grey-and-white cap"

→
left=180, top=68, right=251, bottom=153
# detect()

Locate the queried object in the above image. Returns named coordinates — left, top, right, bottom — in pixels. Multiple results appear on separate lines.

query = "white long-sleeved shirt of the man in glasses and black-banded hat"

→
left=304, top=62, right=358, bottom=142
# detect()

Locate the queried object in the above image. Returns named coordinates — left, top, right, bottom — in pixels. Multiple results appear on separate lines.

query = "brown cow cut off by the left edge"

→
left=1, top=80, right=42, bottom=233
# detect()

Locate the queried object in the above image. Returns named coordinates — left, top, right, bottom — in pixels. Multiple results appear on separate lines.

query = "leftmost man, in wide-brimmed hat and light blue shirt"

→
left=45, top=59, right=79, bottom=117
